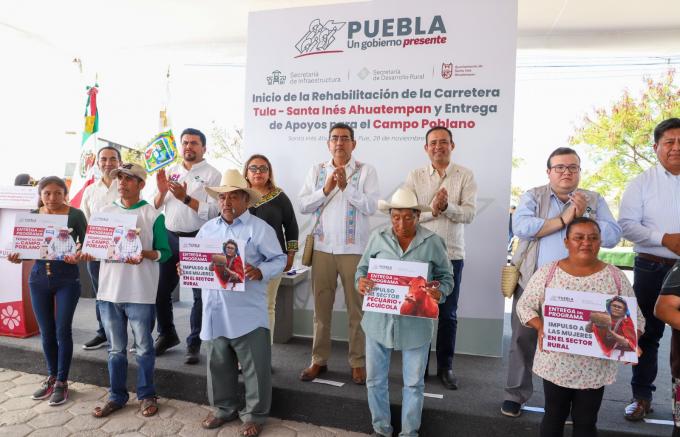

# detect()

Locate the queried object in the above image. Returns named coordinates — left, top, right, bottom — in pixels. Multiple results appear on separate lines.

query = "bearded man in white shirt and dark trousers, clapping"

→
left=154, top=128, right=221, bottom=364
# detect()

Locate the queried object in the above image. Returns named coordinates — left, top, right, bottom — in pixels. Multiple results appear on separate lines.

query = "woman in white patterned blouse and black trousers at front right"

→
left=517, top=217, right=645, bottom=437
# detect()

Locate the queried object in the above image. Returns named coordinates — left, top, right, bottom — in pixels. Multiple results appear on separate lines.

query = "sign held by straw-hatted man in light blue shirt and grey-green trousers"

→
left=179, top=237, right=246, bottom=291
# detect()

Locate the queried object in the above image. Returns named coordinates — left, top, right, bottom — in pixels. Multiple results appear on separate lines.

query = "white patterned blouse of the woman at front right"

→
left=517, top=263, right=645, bottom=389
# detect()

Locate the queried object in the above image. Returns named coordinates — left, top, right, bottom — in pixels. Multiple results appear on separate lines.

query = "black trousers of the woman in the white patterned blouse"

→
left=541, top=379, right=604, bottom=437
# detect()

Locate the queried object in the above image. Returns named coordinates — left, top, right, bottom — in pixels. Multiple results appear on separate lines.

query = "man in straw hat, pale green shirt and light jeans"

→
left=356, top=188, right=453, bottom=436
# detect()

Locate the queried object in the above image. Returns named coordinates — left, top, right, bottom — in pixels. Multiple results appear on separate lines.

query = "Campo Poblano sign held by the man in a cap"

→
left=83, top=213, right=142, bottom=262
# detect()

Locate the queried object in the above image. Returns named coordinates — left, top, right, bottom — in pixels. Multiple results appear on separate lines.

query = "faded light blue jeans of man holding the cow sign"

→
left=366, top=336, right=430, bottom=437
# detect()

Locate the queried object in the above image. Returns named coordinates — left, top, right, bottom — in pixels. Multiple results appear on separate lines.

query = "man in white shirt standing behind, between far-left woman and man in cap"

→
left=80, top=146, right=121, bottom=350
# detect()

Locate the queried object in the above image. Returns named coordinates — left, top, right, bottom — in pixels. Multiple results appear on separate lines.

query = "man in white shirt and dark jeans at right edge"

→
left=619, top=118, right=680, bottom=420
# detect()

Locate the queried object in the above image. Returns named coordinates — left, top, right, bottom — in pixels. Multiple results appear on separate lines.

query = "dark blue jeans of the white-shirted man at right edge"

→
left=630, top=257, right=672, bottom=401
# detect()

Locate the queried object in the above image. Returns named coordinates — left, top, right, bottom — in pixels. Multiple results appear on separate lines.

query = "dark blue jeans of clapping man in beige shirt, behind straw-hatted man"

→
left=437, top=259, right=463, bottom=370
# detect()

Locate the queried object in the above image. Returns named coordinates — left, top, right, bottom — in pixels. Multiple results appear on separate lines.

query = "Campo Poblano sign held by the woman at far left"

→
left=13, top=213, right=76, bottom=260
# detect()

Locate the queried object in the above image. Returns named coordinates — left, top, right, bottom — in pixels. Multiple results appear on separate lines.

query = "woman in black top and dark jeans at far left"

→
left=7, top=176, right=87, bottom=405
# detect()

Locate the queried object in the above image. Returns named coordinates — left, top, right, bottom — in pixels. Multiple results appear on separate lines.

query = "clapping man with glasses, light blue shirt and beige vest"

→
left=501, top=147, right=621, bottom=417
